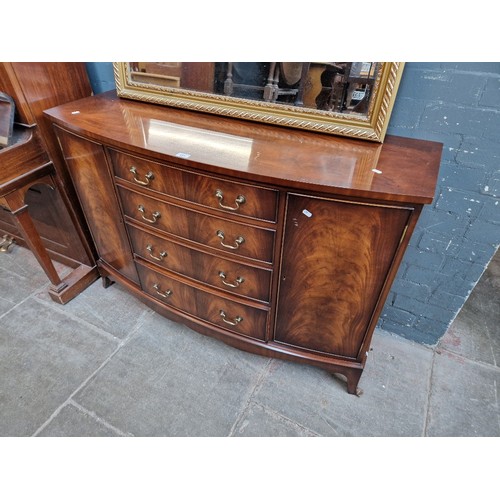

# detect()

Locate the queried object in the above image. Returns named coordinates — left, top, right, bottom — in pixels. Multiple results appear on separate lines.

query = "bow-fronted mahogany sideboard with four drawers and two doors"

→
left=45, top=92, right=442, bottom=394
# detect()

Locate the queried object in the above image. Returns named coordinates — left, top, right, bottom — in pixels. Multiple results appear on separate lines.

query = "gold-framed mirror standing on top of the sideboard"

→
left=113, top=62, right=404, bottom=142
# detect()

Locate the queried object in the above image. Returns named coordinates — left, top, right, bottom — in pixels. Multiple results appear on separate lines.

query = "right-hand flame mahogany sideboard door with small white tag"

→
left=275, top=195, right=411, bottom=359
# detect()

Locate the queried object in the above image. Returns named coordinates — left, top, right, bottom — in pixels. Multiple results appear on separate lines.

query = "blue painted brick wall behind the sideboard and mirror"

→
left=87, top=62, right=500, bottom=345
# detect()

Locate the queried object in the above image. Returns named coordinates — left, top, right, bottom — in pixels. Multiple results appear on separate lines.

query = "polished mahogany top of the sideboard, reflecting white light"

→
left=45, top=91, right=442, bottom=204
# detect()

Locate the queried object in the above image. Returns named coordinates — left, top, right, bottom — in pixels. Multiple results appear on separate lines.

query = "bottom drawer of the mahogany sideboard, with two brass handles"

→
left=137, top=264, right=269, bottom=340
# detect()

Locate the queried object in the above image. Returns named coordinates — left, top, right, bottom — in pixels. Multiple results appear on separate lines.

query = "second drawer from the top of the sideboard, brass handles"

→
left=118, top=187, right=275, bottom=263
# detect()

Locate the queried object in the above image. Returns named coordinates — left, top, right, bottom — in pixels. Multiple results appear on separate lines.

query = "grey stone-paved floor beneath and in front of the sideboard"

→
left=0, top=247, right=500, bottom=437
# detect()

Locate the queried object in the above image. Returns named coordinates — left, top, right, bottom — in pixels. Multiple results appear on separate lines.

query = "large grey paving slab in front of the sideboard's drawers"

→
left=74, top=314, right=268, bottom=436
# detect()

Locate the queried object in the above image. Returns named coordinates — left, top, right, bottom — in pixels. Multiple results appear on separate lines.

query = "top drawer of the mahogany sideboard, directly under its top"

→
left=109, top=150, right=278, bottom=222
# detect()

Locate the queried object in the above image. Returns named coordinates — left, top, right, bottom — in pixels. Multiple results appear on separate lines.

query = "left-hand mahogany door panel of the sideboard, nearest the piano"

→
left=55, top=127, right=139, bottom=283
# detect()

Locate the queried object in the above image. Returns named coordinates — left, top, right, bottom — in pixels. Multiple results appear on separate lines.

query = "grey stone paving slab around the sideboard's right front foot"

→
left=249, top=331, right=432, bottom=436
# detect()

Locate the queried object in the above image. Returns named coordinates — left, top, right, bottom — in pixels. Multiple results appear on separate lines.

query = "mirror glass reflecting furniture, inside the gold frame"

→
left=130, top=62, right=381, bottom=116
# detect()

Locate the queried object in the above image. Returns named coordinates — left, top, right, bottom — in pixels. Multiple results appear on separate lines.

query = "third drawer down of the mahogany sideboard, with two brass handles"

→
left=128, top=225, right=271, bottom=302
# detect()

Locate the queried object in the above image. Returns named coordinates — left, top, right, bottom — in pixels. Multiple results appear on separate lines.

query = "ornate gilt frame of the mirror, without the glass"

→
left=113, top=62, right=404, bottom=142
